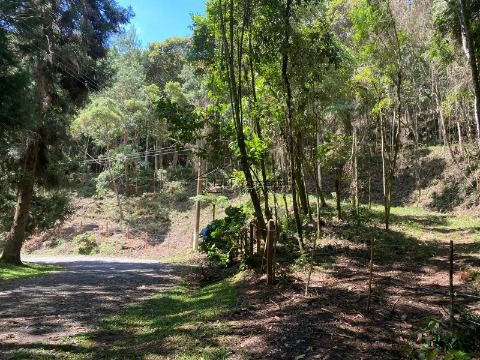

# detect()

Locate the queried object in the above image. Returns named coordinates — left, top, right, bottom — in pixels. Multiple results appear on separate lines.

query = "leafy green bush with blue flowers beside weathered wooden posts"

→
left=200, top=206, right=247, bottom=267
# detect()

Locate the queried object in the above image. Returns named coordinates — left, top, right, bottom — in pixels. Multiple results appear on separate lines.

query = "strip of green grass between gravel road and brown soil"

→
left=11, top=274, right=241, bottom=360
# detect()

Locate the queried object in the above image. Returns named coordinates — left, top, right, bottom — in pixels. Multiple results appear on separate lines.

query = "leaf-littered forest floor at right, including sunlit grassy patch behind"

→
left=225, top=206, right=480, bottom=359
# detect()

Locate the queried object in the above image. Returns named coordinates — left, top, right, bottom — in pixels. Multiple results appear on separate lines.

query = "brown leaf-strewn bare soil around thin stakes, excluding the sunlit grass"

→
left=225, top=233, right=480, bottom=360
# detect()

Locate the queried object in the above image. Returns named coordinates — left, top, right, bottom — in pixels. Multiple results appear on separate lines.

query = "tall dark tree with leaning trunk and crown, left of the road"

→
left=1, top=0, right=131, bottom=264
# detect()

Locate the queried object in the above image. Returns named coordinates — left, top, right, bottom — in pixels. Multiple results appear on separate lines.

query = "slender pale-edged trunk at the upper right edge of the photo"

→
left=458, top=0, right=480, bottom=144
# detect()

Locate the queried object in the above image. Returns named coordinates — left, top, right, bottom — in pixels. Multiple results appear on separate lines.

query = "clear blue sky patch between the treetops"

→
left=117, top=0, right=205, bottom=46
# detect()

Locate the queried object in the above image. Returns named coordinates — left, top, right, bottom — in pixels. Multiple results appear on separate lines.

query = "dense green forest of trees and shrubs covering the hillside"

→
left=0, top=0, right=480, bottom=356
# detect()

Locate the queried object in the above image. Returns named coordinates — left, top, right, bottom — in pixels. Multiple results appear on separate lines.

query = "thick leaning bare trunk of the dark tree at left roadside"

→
left=1, top=139, right=39, bottom=265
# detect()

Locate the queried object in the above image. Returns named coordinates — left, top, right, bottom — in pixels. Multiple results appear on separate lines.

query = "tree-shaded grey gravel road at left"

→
left=0, top=257, right=186, bottom=348
